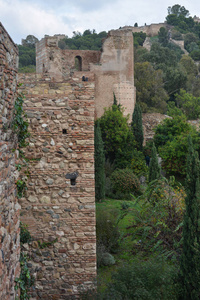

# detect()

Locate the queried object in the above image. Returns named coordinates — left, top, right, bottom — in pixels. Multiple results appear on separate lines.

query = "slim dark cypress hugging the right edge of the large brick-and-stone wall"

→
left=94, top=122, right=105, bottom=201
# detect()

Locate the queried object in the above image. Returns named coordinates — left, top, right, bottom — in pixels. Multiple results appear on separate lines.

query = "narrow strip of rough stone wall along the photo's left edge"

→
left=0, top=23, right=20, bottom=300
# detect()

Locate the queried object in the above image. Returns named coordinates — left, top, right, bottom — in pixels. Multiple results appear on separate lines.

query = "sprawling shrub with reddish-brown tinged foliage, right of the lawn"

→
left=128, top=177, right=185, bottom=258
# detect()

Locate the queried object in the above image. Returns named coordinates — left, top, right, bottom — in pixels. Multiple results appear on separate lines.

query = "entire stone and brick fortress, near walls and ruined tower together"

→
left=0, top=25, right=135, bottom=300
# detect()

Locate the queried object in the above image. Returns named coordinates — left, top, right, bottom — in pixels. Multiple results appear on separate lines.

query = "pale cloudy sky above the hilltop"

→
left=0, top=0, right=200, bottom=44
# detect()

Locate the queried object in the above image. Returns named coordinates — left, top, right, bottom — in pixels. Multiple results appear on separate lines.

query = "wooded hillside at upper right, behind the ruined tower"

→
left=133, top=4, right=200, bottom=113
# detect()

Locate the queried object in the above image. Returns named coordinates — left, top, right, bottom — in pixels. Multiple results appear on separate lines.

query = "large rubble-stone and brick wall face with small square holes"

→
left=19, top=74, right=96, bottom=299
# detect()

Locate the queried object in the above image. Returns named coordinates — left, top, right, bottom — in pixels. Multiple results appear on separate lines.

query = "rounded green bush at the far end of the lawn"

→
left=111, top=169, right=140, bottom=195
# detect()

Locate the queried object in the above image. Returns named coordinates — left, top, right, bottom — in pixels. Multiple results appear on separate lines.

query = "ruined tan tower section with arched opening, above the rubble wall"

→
left=36, top=29, right=136, bottom=118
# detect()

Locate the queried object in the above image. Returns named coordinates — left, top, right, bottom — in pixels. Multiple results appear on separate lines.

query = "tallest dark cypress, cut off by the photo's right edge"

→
left=180, top=136, right=200, bottom=300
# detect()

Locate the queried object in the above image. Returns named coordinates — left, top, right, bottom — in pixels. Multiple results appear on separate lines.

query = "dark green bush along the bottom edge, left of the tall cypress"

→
left=102, top=258, right=178, bottom=300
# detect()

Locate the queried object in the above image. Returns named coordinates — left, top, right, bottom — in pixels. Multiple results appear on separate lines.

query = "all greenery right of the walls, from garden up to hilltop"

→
left=92, top=5, right=200, bottom=300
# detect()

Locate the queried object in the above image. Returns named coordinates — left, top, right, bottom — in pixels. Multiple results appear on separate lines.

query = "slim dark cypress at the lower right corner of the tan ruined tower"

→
left=131, top=103, right=144, bottom=151
